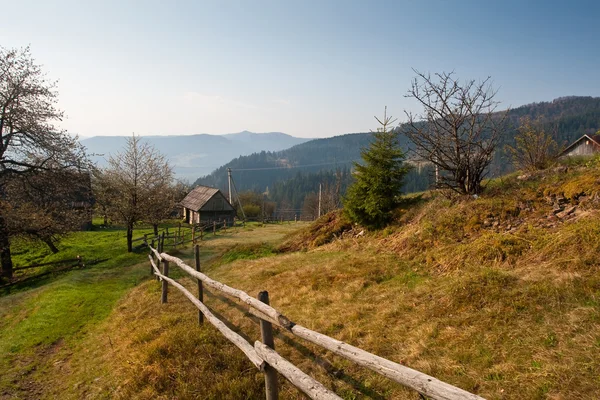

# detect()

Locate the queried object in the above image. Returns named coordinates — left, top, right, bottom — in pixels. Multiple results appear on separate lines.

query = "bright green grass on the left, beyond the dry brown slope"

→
left=0, top=222, right=184, bottom=393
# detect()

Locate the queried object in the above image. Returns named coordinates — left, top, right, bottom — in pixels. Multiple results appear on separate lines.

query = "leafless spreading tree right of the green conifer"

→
left=401, top=71, right=508, bottom=194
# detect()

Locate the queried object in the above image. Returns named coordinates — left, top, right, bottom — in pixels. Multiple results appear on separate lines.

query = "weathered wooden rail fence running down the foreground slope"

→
left=148, top=239, right=483, bottom=400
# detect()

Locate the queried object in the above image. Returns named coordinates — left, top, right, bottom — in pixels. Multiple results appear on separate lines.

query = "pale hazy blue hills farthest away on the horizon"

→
left=81, top=131, right=308, bottom=181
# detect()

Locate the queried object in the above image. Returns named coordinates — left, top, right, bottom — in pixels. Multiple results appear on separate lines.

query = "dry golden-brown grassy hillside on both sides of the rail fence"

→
left=2, top=161, right=600, bottom=399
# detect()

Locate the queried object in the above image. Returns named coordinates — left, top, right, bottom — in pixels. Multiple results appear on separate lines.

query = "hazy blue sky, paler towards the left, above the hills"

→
left=0, top=0, right=600, bottom=137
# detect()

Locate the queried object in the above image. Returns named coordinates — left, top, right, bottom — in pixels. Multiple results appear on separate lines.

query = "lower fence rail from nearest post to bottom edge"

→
left=254, top=341, right=342, bottom=400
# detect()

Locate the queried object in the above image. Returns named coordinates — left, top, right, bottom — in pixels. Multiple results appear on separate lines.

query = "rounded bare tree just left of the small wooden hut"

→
left=99, top=135, right=173, bottom=252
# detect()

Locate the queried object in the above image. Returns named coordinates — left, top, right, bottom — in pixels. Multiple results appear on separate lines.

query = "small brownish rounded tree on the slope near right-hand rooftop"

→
left=506, top=117, right=562, bottom=171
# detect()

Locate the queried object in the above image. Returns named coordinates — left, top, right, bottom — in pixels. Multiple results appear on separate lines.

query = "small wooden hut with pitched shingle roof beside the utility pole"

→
left=180, top=186, right=236, bottom=224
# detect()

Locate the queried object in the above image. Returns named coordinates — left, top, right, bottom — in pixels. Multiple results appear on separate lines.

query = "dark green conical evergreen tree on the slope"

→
left=344, top=107, right=409, bottom=228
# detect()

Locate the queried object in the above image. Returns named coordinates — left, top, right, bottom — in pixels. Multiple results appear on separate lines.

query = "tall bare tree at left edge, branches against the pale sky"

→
left=0, top=47, right=86, bottom=278
